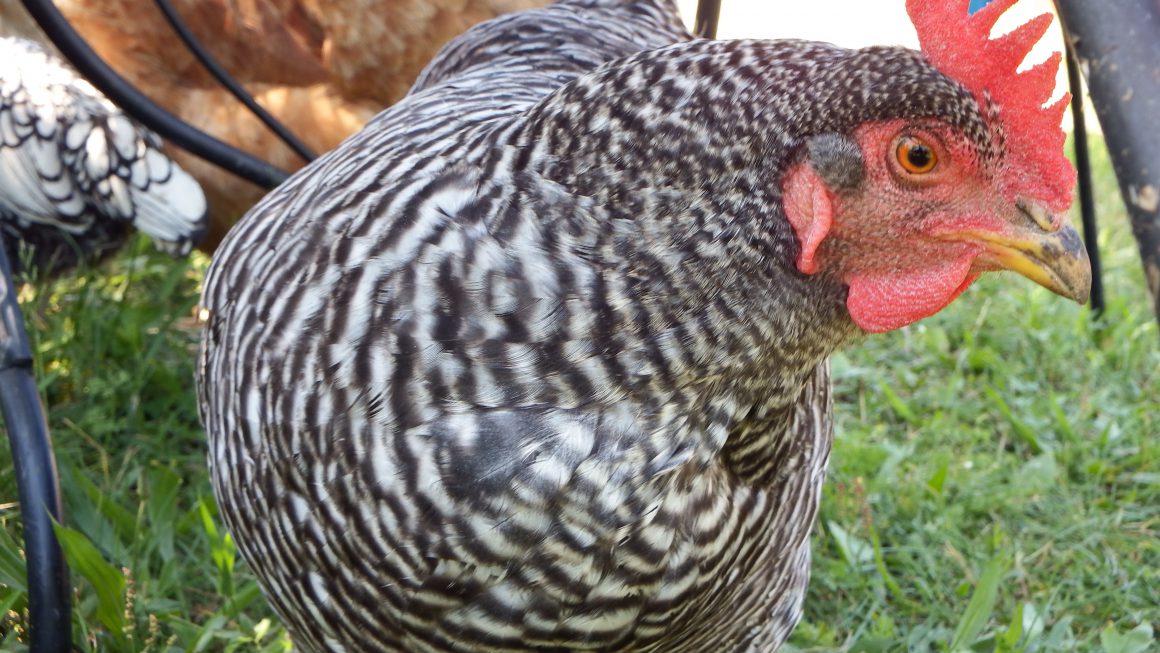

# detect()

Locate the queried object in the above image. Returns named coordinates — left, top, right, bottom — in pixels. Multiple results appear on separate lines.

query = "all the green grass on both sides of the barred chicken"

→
left=0, top=133, right=1160, bottom=653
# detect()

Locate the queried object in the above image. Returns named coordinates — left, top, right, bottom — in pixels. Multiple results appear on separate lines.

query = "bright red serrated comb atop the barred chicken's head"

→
left=906, top=0, right=1075, bottom=211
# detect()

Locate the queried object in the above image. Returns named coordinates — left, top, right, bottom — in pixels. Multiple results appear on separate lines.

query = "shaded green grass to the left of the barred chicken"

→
left=0, top=247, right=289, bottom=652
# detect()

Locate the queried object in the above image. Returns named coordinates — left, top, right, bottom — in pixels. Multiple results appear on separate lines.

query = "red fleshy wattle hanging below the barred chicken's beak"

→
left=844, top=252, right=979, bottom=333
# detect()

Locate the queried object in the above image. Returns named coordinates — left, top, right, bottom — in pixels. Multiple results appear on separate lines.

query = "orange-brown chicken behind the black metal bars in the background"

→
left=0, top=0, right=549, bottom=251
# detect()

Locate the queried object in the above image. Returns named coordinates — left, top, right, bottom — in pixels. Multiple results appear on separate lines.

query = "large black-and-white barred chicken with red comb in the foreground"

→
left=198, top=0, right=1090, bottom=653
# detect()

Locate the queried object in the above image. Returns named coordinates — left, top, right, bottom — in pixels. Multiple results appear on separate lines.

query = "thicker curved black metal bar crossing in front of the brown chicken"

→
left=23, top=0, right=290, bottom=188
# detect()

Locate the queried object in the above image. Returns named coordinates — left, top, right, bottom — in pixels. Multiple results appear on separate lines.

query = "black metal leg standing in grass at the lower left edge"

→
left=0, top=238, right=72, bottom=653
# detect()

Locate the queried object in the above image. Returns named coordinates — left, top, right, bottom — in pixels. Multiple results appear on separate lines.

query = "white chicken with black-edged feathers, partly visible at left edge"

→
left=0, top=37, right=205, bottom=273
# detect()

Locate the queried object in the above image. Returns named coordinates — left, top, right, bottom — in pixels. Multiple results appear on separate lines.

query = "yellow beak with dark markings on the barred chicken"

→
left=963, top=201, right=1092, bottom=304
